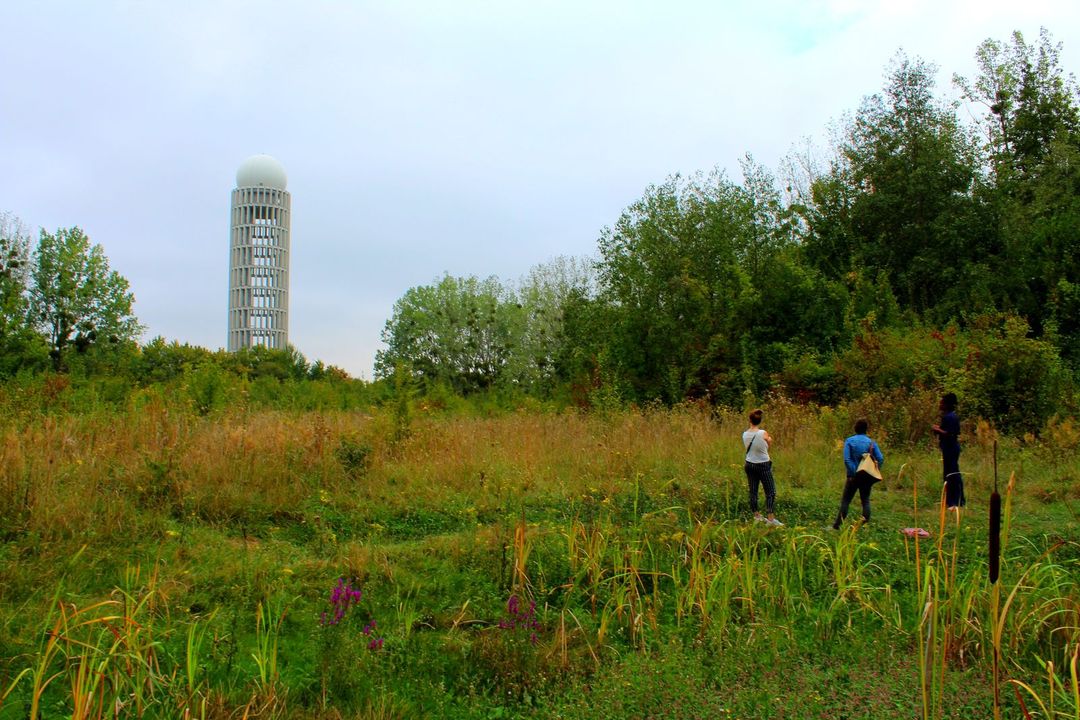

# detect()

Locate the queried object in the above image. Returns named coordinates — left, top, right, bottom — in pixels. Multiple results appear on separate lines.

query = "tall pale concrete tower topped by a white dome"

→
left=228, top=155, right=291, bottom=352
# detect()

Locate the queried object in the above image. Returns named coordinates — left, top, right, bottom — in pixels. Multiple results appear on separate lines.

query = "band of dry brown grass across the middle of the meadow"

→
left=0, top=399, right=1075, bottom=546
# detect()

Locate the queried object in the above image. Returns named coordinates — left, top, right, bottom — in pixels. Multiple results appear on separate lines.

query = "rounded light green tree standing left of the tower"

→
left=29, top=227, right=143, bottom=370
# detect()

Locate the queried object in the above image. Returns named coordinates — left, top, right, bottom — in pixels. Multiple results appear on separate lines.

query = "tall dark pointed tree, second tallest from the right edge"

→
left=842, top=55, right=994, bottom=317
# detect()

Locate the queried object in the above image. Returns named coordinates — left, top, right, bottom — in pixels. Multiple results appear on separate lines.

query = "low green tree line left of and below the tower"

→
left=0, top=214, right=367, bottom=413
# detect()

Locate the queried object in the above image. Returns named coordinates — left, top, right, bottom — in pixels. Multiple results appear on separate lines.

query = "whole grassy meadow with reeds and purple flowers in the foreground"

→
left=0, top=403, right=1080, bottom=720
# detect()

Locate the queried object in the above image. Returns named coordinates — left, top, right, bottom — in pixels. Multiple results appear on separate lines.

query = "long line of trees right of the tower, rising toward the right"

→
left=376, top=30, right=1080, bottom=425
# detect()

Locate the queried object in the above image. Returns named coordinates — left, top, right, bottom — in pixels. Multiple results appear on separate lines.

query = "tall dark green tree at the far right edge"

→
left=954, top=29, right=1080, bottom=347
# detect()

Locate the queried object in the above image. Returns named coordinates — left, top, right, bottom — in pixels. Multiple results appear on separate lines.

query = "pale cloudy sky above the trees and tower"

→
left=0, top=0, right=1080, bottom=379
